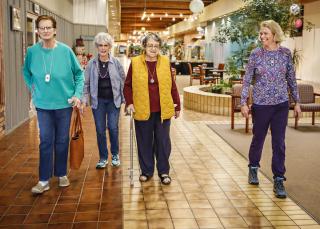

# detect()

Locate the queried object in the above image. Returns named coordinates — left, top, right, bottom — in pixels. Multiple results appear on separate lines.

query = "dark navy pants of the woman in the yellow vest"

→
left=134, top=112, right=171, bottom=176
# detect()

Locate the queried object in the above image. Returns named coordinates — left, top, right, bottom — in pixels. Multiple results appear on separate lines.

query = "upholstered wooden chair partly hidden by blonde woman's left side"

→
left=231, top=84, right=252, bottom=133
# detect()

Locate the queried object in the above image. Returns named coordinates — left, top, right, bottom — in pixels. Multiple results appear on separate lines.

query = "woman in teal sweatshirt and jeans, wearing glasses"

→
left=23, top=15, right=84, bottom=194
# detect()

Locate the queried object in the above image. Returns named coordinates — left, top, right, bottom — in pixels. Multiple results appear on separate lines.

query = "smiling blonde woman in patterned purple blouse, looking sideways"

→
left=241, top=20, right=301, bottom=198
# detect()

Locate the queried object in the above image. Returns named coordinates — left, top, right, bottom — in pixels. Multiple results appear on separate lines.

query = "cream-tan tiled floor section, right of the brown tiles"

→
left=121, top=106, right=320, bottom=229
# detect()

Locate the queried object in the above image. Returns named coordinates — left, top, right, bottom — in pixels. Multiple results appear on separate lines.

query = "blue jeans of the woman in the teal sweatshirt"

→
left=36, top=107, right=72, bottom=181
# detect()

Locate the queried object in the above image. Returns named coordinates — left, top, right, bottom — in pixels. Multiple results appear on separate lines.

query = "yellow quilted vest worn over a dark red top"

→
left=131, top=54, right=174, bottom=121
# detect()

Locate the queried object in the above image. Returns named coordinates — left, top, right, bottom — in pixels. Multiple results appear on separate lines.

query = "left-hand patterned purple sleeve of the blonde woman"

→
left=240, top=51, right=256, bottom=106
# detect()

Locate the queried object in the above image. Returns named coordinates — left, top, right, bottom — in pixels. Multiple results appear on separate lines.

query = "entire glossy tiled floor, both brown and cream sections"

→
left=0, top=74, right=320, bottom=229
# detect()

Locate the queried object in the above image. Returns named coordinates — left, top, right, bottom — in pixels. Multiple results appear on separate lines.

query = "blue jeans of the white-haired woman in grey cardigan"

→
left=92, top=98, right=120, bottom=160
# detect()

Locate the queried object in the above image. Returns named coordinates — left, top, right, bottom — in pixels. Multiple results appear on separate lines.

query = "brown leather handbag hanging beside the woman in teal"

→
left=69, top=108, right=84, bottom=169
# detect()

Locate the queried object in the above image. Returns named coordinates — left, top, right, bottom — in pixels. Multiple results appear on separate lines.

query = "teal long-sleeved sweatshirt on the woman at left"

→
left=23, top=42, right=84, bottom=110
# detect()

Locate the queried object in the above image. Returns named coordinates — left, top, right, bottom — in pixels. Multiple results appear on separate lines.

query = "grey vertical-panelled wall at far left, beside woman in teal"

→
left=1, top=0, right=29, bottom=132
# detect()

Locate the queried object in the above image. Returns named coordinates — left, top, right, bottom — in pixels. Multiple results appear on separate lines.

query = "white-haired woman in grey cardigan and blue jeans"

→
left=82, top=32, right=125, bottom=169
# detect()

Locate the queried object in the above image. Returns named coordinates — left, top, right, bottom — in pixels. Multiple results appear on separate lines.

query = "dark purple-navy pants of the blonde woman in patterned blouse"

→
left=249, top=102, right=289, bottom=177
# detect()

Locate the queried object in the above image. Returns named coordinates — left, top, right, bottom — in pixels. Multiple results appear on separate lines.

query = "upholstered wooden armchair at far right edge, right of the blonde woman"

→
left=294, top=84, right=320, bottom=129
